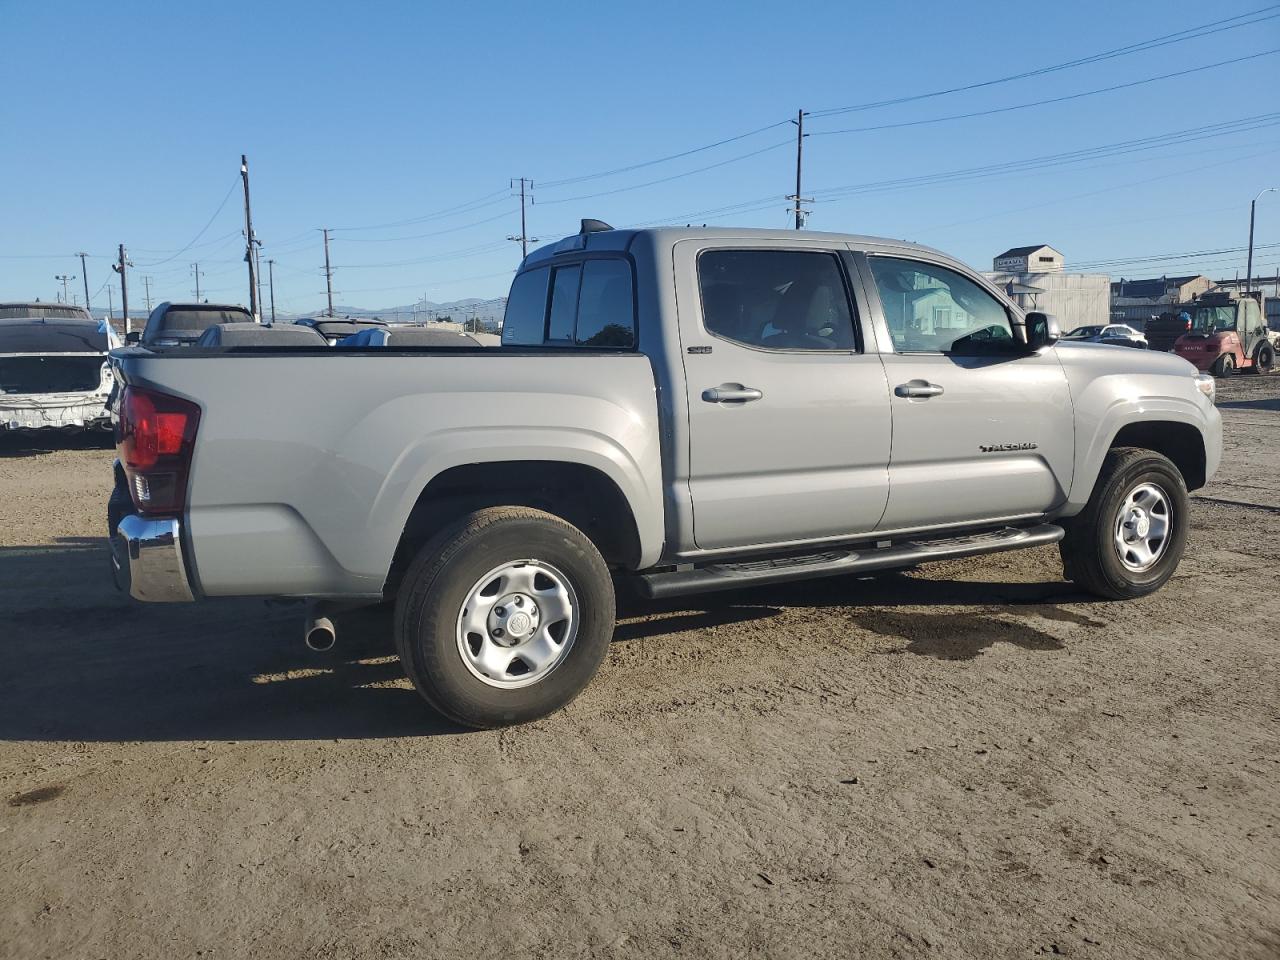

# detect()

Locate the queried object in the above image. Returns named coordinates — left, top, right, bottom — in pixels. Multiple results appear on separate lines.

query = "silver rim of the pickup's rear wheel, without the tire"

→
left=458, top=559, right=579, bottom=690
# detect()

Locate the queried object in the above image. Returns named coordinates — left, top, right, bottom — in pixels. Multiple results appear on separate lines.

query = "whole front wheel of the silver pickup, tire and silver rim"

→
left=1059, top=447, right=1189, bottom=600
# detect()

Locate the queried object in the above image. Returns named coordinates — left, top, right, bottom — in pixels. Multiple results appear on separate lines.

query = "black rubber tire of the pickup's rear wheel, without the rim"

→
left=394, top=507, right=616, bottom=728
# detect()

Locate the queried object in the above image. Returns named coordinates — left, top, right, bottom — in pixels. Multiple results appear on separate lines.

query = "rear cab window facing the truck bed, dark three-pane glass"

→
left=502, top=257, right=636, bottom=349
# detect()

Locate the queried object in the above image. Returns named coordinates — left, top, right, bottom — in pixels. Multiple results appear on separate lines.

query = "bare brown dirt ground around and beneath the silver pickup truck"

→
left=0, top=376, right=1280, bottom=960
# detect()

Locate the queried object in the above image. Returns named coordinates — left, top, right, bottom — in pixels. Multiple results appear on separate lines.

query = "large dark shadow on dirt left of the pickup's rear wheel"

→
left=0, top=539, right=461, bottom=741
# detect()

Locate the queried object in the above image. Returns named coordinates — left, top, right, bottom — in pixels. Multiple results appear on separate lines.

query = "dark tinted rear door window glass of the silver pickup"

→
left=698, top=250, right=856, bottom=351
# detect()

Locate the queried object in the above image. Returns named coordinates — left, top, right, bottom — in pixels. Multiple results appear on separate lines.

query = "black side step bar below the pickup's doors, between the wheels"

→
left=636, top=524, right=1065, bottom=600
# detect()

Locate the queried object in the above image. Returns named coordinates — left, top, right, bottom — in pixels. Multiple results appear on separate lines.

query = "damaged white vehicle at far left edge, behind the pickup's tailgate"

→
left=0, top=303, right=119, bottom=433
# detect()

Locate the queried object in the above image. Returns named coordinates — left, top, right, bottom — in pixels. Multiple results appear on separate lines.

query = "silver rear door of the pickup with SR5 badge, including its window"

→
left=676, top=241, right=890, bottom=549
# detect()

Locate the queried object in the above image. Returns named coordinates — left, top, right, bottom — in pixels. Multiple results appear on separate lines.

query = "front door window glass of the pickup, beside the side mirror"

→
left=869, top=256, right=1014, bottom=355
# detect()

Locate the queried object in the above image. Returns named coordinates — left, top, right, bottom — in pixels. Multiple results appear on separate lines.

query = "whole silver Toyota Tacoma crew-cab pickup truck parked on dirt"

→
left=109, top=221, right=1221, bottom=727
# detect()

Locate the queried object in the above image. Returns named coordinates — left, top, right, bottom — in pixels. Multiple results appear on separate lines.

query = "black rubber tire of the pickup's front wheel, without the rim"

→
left=1059, top=447, right=1189, bottom=600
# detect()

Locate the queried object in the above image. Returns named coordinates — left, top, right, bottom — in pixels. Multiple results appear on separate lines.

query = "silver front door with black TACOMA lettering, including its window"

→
left=859, top=255, right=1075, bottom=531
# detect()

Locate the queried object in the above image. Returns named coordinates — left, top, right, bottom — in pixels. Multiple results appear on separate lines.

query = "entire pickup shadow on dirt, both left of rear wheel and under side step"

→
left=0, top=538, right=1094, bottom=741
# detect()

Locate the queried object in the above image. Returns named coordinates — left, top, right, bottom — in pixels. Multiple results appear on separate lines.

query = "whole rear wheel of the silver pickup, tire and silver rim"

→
left=396, top=507, right=614, bottom=728
